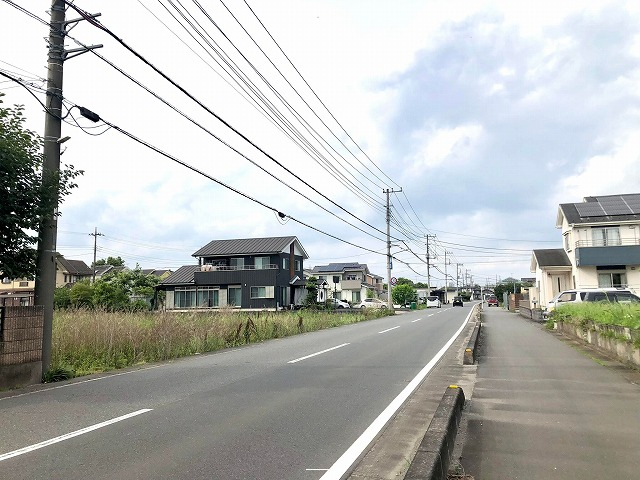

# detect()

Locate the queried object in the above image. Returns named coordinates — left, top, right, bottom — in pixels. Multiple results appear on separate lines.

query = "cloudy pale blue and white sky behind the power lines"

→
left=0, top=0, right=640, bottom=286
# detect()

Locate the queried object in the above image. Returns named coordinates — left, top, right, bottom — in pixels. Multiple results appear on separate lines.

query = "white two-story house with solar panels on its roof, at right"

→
left=531, top=193, right=640, bottom=305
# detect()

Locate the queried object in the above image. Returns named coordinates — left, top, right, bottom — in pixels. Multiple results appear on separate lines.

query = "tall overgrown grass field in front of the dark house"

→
left=50, top=309, right=387, bottom=381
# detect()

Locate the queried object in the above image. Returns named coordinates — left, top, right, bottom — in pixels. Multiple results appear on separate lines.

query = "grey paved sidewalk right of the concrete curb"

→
left=460, top=308, right=640, bottom=480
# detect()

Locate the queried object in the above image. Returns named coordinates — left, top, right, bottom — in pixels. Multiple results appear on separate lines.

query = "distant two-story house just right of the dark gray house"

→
left=311, top=262, right=382, bottom=303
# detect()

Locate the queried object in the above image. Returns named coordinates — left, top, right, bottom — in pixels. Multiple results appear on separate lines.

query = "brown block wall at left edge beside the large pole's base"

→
left=0, top=306, right=44, bottom=388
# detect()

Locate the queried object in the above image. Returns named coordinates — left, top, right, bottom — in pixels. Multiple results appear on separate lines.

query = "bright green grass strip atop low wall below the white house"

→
left=551, top=302, right=640, bottom=330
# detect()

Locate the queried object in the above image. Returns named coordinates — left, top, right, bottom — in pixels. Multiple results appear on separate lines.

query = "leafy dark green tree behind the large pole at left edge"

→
left=0, top=94, right=83, bottom=279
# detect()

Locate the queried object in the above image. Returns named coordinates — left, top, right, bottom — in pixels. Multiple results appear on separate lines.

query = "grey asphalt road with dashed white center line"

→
left=0, top=305, right=471, bottom=480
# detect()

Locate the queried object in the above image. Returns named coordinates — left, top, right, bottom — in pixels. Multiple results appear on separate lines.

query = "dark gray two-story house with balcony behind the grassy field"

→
left=158, top=237, right=309, bottom=310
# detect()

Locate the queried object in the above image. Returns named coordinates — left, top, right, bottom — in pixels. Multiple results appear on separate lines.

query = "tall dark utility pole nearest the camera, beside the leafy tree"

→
left=34, top=0, right=101, bottom=374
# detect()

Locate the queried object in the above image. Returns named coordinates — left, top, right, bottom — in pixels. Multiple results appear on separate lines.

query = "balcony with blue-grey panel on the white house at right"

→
left=576, top=239, right=640, bottom=267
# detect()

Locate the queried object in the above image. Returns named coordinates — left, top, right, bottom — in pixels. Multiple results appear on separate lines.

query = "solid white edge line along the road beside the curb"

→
left=320, top=309, right=473, bottom=480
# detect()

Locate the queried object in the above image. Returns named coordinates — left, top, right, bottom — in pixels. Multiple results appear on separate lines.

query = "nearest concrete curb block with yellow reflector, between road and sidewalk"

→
left=404, top=385, right=464, bottom=480
